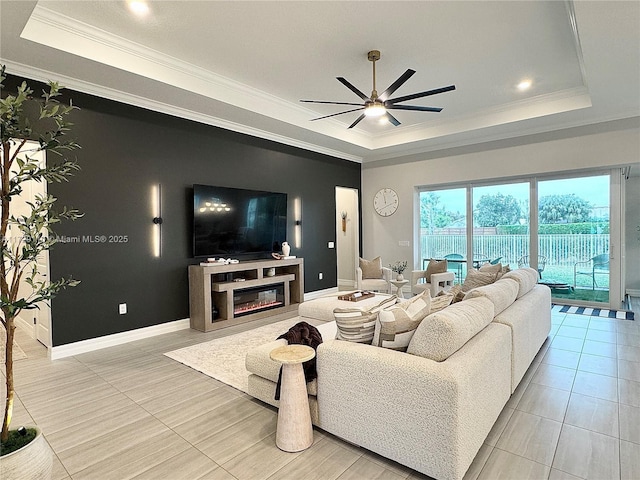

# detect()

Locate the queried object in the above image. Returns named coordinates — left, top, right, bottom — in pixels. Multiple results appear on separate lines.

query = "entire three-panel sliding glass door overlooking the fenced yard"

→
left=419, top=173, right=620, bottom=308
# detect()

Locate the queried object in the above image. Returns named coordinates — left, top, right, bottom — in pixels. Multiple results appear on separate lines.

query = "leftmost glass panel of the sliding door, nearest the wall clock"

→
left=420, top=188, right=467, bottom=282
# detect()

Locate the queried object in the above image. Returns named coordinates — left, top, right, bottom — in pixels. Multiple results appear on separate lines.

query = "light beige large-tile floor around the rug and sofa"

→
left=0, top=304, right=640, bottom=480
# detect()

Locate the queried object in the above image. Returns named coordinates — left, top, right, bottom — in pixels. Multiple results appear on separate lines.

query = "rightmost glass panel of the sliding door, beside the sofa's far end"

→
left=538, top=175, right=610, bottom=304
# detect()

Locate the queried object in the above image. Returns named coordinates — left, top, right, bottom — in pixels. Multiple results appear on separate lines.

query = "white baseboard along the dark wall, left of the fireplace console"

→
left=49, top=318, right=190, bottom=360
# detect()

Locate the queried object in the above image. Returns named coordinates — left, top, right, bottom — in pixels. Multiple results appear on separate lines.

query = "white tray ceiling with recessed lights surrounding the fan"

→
left=0, top=0, right=640, bottom=162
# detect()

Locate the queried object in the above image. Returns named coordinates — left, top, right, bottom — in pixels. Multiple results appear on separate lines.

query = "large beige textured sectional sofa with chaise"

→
left=246, top=268, right=551, bottom=480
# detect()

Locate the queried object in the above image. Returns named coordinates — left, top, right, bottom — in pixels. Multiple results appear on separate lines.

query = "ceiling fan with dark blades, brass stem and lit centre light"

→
left=300, top=50, right=456, bottom=128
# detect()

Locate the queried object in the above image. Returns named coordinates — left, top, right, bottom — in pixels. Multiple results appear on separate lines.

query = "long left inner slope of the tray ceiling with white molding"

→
left=21, top=4, right=371, bottom=149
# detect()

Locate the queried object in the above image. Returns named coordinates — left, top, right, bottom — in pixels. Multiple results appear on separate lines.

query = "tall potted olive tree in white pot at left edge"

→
left=0, top=66, right=82, bottom=479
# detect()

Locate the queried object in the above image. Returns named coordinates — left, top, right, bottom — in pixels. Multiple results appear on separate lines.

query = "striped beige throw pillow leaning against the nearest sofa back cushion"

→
left=372, top=291, right=431, bottom=352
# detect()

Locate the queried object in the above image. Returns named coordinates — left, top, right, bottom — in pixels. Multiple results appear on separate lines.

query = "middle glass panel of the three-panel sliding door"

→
left=472, top=182, right=530, bottom=269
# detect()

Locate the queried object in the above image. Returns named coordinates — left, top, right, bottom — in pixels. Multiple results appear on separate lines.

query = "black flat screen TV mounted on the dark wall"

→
left=193, top=185, right=287, bottom=260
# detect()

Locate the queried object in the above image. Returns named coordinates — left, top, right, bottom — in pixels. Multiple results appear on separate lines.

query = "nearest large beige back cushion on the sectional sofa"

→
left=407, top=297, right=493, bottom=362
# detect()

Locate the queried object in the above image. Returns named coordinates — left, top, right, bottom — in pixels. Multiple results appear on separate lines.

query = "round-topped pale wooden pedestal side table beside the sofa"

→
left=269, top=345, right=316, bottom=452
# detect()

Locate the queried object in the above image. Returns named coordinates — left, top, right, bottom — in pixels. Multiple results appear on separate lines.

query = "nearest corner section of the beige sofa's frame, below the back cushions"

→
left=317, top=323, right=511, bottom=480
